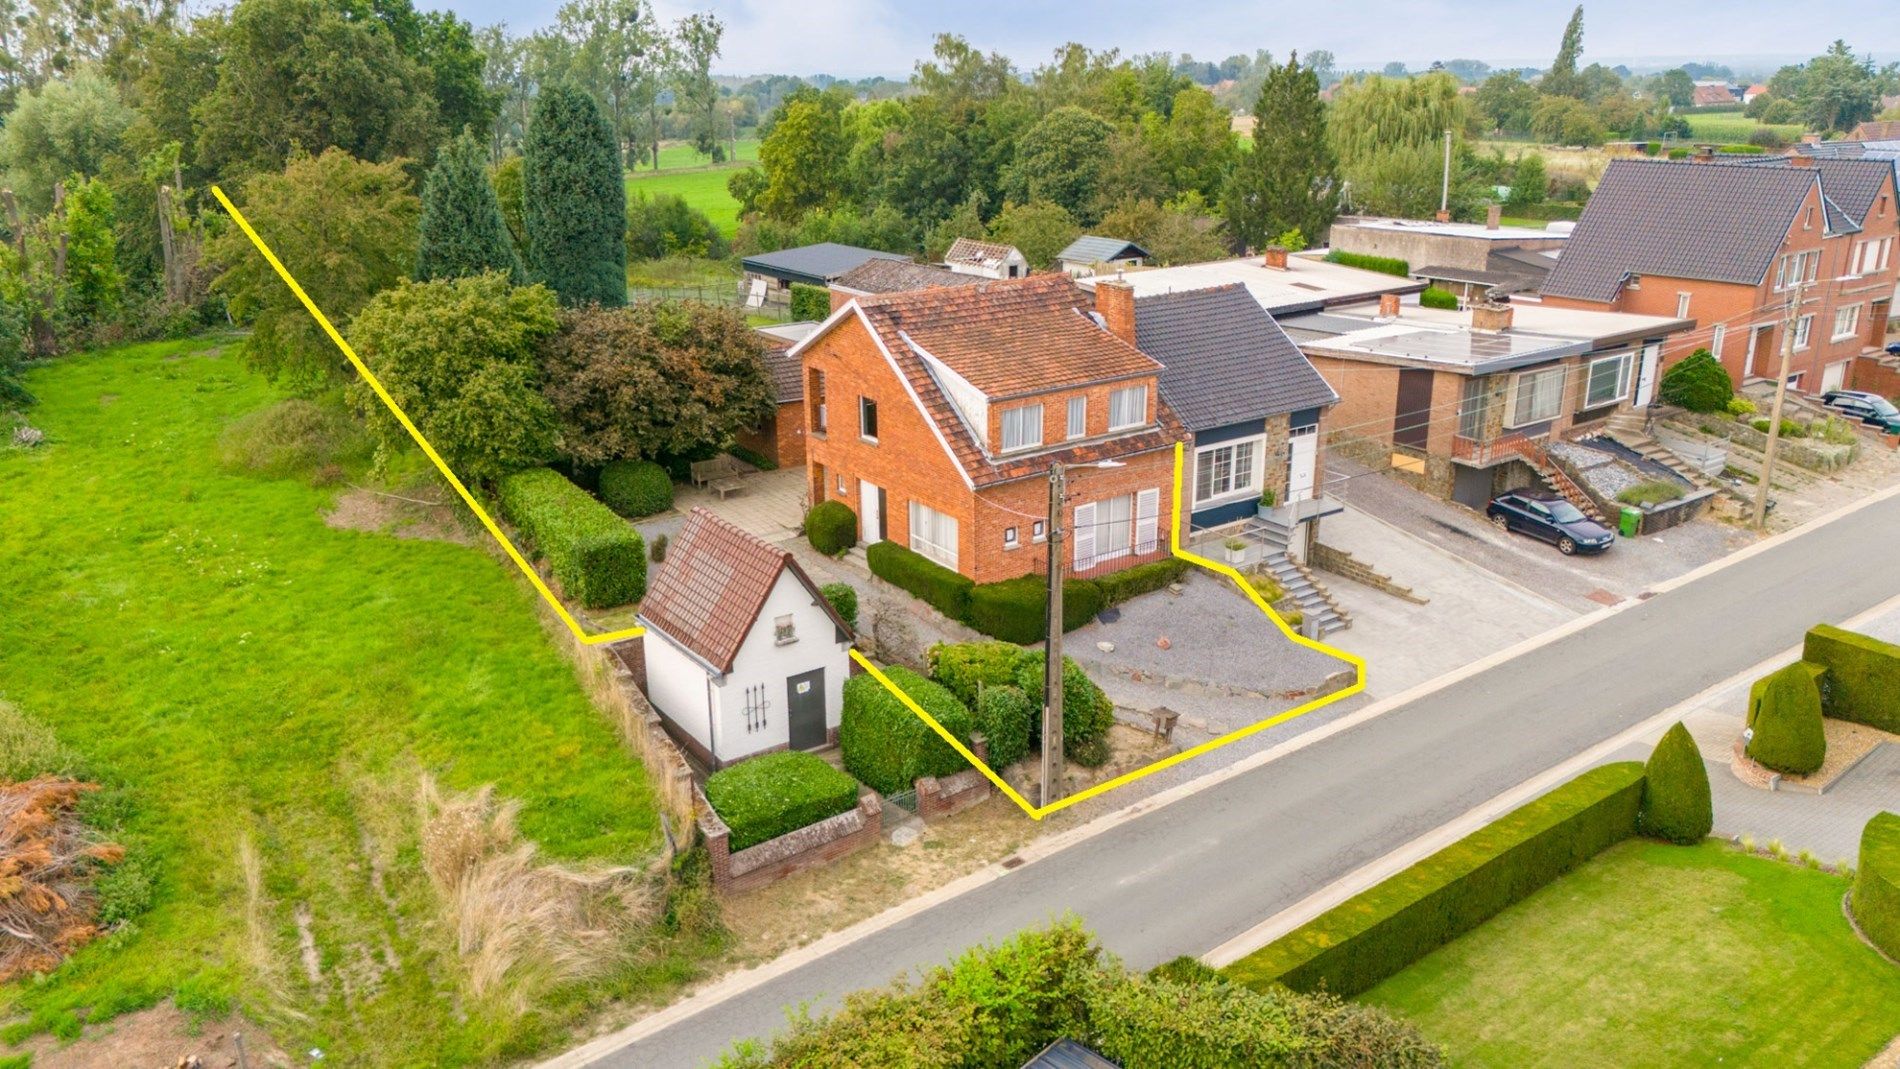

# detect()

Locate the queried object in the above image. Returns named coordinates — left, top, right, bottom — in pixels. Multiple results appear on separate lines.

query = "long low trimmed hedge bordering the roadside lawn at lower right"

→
left=1226, top=761, right=1644, bottom=999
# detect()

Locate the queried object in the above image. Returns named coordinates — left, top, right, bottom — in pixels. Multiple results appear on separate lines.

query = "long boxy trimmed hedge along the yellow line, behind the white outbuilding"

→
left=500, top=467, right=646, bottom=610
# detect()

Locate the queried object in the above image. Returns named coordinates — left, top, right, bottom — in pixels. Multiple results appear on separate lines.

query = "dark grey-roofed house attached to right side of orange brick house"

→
left=1134, top=283, right=1340, bottom=534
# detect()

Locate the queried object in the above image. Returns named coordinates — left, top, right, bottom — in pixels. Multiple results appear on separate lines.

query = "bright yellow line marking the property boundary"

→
left=211, top=186, right=1366, bottom=820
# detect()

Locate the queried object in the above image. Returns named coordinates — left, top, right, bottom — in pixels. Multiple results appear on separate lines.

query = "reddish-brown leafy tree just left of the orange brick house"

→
left=542, top=302, right=773, bottom=463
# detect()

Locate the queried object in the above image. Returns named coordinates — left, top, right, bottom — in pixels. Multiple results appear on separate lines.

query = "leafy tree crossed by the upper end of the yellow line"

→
left=205, top=148, right=422, bottom=389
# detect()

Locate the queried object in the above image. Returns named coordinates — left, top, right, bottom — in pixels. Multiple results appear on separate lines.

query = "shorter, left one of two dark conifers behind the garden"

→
left=416, top=131, right=524, bottom=283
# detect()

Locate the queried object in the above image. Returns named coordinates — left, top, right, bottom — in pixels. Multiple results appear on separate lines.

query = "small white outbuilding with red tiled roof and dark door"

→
left=638, top=509, right=851, bottom=769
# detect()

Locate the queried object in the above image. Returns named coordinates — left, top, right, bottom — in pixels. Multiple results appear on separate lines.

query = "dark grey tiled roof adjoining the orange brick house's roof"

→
left=1134, top=283, right=1340, bottom=431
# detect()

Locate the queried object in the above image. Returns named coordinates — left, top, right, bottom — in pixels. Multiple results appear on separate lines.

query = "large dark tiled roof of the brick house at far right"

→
left=1543, top=159, right=1818, bottom=302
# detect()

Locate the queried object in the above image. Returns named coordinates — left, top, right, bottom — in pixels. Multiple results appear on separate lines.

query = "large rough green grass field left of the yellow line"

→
left=0, top=338, right=690, bottom=1065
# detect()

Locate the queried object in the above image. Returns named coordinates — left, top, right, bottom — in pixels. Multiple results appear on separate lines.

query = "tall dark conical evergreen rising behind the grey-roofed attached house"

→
left=1222, top=53, right=1340, bottom=247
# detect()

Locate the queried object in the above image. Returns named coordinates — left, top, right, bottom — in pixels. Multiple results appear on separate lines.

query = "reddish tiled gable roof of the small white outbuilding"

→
left=640, top=509, right=849, bottom=672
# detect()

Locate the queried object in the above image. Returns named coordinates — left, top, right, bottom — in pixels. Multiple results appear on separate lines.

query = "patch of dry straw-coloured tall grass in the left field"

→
left=416, top=775, right=659, bottom=1012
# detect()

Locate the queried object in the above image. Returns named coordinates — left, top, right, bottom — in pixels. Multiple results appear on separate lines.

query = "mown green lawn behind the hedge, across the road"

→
left=1364, top=841, right=1900, bottom=1069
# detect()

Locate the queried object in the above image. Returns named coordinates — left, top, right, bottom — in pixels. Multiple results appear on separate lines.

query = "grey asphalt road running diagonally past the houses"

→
left=593, top=497, right=1900, bottom=1069
